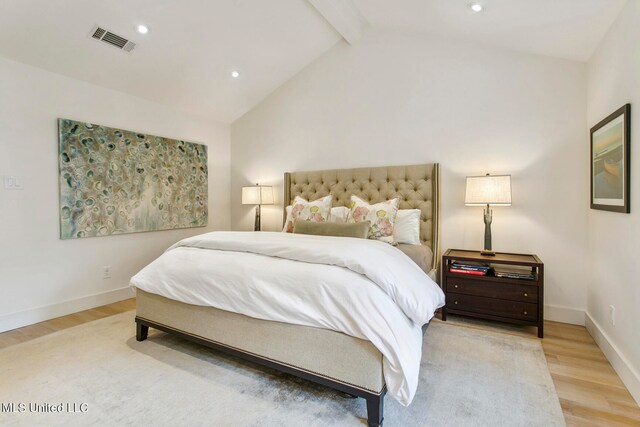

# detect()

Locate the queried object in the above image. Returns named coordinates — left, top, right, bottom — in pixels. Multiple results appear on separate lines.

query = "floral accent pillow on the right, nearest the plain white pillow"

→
left=347, top=195, right=400, bottom=245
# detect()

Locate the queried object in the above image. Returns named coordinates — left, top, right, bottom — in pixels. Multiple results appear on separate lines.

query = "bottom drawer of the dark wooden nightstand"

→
left=447, top=292, right=538, bottom=321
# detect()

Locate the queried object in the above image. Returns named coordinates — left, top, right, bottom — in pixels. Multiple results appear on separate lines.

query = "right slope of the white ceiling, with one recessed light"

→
left=354, top=0, right=636, bottom=61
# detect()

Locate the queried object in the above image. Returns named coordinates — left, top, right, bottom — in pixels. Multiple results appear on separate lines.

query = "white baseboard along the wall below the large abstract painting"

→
left=0, top=286, right=135, bottom=332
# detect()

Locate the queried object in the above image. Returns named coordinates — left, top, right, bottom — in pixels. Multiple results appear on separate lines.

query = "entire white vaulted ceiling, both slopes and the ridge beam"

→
left=0, top=0, right=625, bottom=123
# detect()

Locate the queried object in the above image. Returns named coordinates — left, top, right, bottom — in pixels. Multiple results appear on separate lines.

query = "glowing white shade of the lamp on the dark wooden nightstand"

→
left=464, top=175, right=511, bottom=206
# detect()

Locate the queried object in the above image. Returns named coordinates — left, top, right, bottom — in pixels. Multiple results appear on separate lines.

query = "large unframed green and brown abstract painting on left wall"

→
left=58, top=119, right=208, bottom=239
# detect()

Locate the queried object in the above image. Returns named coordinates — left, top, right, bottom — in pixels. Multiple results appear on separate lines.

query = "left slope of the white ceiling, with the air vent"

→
left=0, top=0, right=340, bottom=123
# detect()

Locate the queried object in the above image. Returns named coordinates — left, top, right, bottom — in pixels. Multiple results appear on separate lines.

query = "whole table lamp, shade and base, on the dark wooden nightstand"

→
left=464, top=174, right=511, bottom=256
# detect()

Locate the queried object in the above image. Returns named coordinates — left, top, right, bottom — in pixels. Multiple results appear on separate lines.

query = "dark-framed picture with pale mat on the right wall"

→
left=591, top=104, right=631, bottom=213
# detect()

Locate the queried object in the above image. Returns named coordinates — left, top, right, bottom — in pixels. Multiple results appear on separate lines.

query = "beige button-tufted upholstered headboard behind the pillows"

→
left=284, top=163, right=440, bottom=269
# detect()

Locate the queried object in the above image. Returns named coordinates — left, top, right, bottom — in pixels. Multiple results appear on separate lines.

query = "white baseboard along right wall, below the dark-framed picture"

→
left=585, top=313, right=640, bottom=405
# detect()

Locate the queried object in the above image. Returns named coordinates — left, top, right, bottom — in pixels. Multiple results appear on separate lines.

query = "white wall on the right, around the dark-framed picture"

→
left=585, top=0, right=640, bottom=402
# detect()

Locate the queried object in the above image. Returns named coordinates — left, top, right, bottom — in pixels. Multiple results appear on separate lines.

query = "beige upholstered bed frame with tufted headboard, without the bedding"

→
left=132, top=164, right=439, bottom=426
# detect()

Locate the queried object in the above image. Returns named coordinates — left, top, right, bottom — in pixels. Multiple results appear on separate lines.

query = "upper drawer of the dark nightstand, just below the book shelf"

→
left=447, top=277, right=538, bottom=304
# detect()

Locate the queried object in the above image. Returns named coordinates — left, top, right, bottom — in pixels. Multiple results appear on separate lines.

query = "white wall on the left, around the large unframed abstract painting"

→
left=0, top=59, right=230, bottom=331
